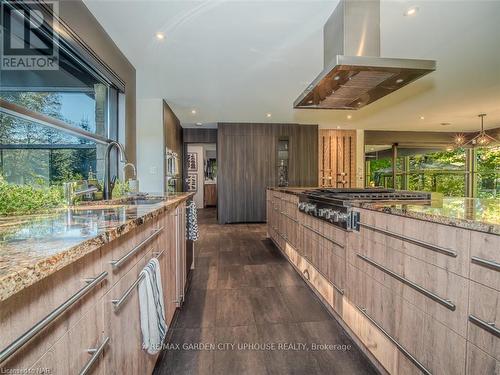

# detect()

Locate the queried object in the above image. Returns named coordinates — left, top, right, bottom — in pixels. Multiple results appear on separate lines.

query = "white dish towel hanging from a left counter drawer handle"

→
left=138, top=258, right=167, bottom=354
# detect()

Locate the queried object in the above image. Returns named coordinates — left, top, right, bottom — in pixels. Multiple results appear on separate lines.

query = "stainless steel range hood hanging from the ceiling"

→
left=293, top=0, right=436, bottom=109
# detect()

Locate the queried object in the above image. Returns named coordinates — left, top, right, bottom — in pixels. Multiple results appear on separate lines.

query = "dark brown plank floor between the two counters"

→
left=155, top=209, right=376, bottom=375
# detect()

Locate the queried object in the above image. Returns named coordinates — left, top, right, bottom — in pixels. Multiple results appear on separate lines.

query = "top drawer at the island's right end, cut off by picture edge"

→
left=470, top=231, right=500, bottom=290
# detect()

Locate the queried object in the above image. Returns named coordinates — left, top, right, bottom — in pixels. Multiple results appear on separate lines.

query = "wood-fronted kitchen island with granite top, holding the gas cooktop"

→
left=267, top=188, right=500, bottom=374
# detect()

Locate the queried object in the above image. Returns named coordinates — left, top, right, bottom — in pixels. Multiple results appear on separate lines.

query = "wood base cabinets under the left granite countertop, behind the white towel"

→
left=0, top=203, right=186, bottom=375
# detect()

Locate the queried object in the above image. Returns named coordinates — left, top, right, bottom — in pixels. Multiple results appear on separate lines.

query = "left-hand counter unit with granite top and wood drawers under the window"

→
left=0, top=193, right=192, bottom=374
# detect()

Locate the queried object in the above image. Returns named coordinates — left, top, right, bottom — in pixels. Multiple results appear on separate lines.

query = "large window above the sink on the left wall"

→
left=0, top=1, right=120, bottom=185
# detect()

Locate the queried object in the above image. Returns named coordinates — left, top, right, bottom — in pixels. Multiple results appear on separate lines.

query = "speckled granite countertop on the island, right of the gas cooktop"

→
left=360, top=198, right=500, bottom=235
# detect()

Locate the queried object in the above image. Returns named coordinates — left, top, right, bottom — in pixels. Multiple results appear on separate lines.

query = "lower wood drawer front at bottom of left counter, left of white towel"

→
left=32, top=303, right=109, bottom=375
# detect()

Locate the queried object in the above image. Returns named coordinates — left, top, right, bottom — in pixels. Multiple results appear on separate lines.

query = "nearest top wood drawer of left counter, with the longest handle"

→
left=0, top=251, right=107, bottom=368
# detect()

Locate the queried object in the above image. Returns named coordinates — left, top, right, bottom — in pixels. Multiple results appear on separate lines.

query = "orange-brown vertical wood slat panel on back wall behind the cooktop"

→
left=318, top=129, right=356, bottom=188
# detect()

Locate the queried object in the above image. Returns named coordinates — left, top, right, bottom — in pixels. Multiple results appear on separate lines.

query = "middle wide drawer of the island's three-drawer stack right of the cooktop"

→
left=349, top=239, right=469, bottom=337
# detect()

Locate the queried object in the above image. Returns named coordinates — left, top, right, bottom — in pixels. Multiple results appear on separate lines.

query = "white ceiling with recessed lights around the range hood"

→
left=84, top=0, right=500, bottom=131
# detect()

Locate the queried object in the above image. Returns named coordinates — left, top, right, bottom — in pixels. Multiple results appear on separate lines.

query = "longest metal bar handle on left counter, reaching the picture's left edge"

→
left=0, top=271, right=108, bottom=363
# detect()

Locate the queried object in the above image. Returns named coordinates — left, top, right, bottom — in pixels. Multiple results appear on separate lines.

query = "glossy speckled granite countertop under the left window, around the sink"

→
left=0, top=193, right=193, bottom=301
